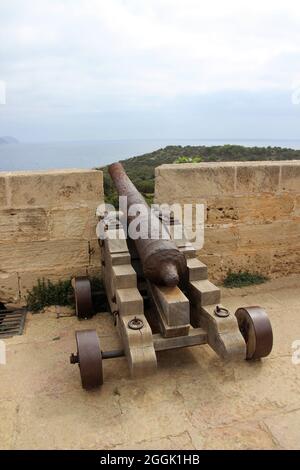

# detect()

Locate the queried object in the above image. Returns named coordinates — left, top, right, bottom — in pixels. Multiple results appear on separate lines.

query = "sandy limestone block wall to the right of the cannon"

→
left=155, top=161, right=300, bottom=280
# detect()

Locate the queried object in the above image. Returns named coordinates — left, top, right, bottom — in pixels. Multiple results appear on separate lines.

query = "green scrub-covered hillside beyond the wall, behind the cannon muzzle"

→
left=101, top=145, right=300, bottom=206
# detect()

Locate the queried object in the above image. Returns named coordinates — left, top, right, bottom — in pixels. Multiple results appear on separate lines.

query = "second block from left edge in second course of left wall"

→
left=48, top=207, right=97, bottom=240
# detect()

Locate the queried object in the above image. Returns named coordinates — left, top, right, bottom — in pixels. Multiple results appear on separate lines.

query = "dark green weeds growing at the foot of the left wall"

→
left=26, top=278, right=107, bottom=312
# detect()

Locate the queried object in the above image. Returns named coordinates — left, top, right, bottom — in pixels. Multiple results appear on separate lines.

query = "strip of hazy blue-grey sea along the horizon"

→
left=0, top=139, right=300, bottom=171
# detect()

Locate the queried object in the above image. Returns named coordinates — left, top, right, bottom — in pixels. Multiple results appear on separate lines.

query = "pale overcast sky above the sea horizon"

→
left=0, top=0, right=300, bottom=142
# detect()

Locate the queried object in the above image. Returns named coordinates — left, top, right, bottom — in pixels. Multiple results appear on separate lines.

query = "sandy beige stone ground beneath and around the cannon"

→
left=0, top=276, right=300, bottom=449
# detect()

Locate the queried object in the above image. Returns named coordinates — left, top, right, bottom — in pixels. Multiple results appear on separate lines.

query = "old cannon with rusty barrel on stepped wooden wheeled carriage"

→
left=70, top=163, right=273, bottom=389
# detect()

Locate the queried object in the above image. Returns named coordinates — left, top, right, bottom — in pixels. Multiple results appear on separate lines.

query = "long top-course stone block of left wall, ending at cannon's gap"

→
left=6, top=170, right=103, bottom=208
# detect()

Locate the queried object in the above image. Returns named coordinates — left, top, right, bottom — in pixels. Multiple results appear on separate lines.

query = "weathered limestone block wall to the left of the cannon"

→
left=0, top=170, right=103, bottom=302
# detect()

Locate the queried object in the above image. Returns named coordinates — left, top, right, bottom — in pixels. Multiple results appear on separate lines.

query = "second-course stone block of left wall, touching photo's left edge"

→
left=0, top=209, right=49, bottom=243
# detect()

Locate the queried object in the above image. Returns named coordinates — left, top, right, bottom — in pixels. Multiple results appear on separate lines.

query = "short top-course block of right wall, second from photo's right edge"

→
left=236, top=163, right=280, bottom=194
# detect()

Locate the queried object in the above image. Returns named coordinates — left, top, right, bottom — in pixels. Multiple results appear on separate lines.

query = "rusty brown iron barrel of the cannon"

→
left=109, top=163, right=187, bottom=287
